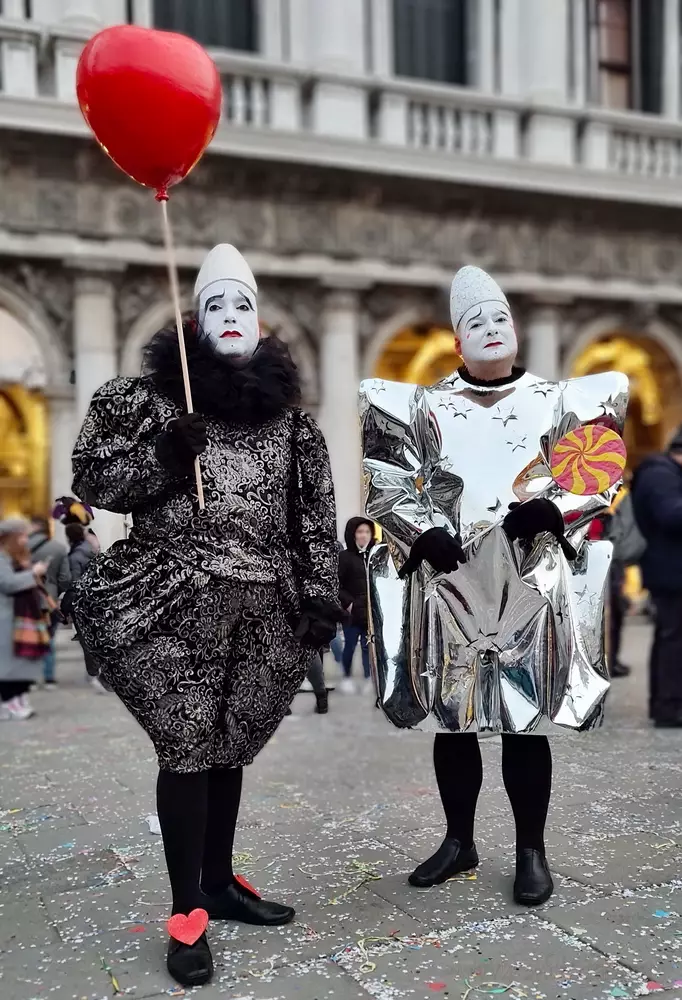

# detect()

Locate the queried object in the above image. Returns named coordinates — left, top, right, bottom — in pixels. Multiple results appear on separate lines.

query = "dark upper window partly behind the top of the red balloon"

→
left=154, top=0, right=258, bottom=52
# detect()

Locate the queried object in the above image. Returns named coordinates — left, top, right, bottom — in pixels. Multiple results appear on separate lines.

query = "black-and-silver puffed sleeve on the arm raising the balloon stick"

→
left=73, top=378, right=185, bottom=514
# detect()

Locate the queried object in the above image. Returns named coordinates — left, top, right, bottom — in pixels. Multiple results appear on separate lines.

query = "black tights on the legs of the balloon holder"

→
left=156, top=767, right=242, bottom=913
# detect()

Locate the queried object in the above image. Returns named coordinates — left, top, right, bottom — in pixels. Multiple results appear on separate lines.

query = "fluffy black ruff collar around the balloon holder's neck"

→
left=144, top=323, right=300, bottom=424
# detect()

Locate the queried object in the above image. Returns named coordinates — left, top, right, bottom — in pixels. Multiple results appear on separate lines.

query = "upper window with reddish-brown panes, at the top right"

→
left=589, top=0, right=663, bottom=113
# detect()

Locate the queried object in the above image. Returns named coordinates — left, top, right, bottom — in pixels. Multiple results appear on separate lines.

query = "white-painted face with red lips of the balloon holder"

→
left=199, top=278, right=260, bottom=361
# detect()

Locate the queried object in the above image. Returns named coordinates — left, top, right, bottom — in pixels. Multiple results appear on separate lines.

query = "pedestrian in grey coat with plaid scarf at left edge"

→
left=0, top=520, right=49, bottom=722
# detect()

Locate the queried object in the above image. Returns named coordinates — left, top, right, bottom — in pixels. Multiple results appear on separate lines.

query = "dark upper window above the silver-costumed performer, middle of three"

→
left=393, top=0, right=468, bottom=84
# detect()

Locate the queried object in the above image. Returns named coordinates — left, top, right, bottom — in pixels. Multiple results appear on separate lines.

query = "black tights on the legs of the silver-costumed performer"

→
left=433, top=733, right=552, bottom=852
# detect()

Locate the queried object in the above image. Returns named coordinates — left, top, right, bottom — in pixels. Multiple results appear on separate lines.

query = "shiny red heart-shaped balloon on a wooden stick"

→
left=76, top=24, right=222, bottom=197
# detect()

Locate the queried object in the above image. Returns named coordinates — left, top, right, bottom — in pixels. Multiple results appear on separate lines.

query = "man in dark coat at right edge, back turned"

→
left=632, top=427, right=682, bottom=727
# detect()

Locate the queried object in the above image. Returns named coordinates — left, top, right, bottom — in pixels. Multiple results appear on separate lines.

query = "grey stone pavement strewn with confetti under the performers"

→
left=0, top=625, right=682, bottom=1000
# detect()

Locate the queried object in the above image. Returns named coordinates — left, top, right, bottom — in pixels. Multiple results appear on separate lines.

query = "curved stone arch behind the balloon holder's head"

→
left=120, top=293, right=319, bottom=406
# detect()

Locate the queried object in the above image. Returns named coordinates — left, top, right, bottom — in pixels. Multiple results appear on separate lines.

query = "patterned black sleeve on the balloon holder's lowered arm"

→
left=292, top=409, right=339, bottom=605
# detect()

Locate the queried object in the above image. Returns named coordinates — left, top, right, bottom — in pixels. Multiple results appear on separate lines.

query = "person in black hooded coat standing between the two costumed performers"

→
left=339, top=517, right=375, bottom=693
